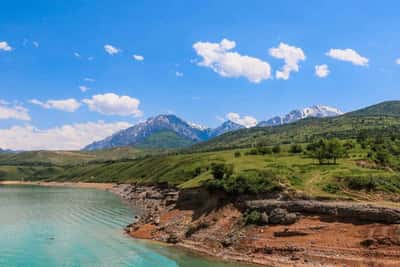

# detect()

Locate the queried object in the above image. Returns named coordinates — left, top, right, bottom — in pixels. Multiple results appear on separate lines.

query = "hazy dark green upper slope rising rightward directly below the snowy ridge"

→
left=190, top=101, right=400, bottom=151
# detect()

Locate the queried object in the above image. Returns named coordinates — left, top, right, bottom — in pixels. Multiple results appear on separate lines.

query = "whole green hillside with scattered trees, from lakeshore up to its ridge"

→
left=0, top=102, right=400, bottom=200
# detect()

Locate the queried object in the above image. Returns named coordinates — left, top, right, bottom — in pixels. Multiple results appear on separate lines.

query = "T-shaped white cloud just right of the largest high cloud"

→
left=269, top=43, right=306, bottom=80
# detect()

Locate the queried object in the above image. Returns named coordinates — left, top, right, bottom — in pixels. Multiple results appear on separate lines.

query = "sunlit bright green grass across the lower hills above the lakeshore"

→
left=0, top=140, right=400, bottom=201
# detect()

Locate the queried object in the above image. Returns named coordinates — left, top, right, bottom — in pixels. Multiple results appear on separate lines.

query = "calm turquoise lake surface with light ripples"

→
left=0, top=186, right=247, bottom=267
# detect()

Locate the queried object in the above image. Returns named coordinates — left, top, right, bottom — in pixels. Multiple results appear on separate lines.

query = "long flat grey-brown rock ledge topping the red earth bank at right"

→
left=245, top=199, right=400, bottom=224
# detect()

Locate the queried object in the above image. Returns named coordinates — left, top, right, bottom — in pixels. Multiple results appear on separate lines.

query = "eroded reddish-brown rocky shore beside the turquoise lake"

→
left=109, top=185, right=400, bottom=266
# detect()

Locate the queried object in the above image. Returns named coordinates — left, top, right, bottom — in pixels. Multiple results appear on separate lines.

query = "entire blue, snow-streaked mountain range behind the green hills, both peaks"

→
left=83, top=105, right=343, bottom=151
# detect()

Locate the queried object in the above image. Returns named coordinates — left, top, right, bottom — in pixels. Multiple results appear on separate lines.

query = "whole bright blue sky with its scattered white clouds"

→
left=0, top=0, right=400, bottom=150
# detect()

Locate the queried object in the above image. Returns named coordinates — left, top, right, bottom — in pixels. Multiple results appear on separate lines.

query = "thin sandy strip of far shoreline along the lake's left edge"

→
left=0, top=181, right=115, bottom=190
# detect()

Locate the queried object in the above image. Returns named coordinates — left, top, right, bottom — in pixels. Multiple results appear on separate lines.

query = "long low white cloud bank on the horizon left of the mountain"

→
left=0, top=121, right=131, bottom=150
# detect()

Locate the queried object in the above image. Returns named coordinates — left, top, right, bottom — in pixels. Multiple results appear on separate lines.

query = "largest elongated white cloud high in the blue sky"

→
left=193, top=39, right=271, bottom=83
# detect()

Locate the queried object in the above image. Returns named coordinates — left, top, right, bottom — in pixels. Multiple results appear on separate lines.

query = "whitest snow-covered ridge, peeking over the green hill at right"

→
left=257, top=105, right=343, bottom=127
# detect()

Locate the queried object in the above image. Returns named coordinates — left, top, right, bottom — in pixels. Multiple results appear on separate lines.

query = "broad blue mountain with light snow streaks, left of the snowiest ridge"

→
left=83, top=115, right=244, bottom=150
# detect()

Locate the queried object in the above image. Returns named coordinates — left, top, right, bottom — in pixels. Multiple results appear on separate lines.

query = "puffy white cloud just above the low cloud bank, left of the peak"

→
left=82, top=93, right=142, bottom=117
